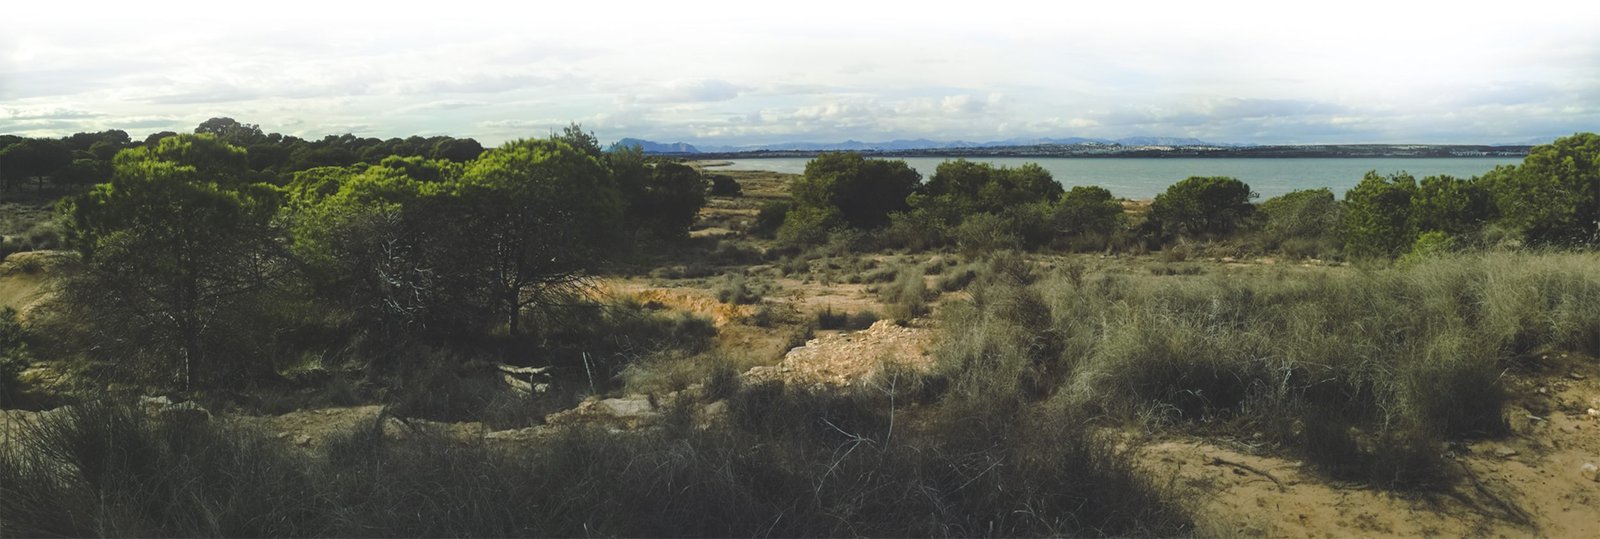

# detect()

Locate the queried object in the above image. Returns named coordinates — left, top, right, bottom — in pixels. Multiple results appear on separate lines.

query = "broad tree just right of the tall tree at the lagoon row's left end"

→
left=923, top=158, right=1062, bottom=213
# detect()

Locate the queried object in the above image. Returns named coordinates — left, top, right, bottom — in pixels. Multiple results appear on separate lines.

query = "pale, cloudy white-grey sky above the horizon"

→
left=0, top=0, right=1600, bottom=146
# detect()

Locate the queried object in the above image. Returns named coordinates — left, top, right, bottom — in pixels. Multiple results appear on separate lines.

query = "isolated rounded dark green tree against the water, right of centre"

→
left=1150, top=176, right=1256, bottom=237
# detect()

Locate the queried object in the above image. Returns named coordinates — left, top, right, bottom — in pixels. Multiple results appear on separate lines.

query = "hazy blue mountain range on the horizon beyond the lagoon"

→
left=618, top=136, right=1222, bottom=154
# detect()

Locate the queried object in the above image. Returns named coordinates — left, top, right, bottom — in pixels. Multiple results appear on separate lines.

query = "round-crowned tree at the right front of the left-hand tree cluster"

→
left=453, top=139, right=622, bottom=334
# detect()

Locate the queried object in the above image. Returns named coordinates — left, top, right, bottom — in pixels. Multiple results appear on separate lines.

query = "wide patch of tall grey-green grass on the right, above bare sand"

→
left=939, top=253, right=1600, bottom=488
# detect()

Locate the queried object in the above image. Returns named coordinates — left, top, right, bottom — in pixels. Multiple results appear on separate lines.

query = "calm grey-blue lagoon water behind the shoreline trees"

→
left=712, top=157, right=1522, bottom=200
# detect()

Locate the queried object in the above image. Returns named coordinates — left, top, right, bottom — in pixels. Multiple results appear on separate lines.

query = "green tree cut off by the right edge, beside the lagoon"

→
left=1483, top=133, right=1600, bottom=245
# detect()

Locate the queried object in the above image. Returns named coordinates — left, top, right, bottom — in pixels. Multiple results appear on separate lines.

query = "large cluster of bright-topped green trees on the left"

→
left=23, top=122, right=710, bottom=389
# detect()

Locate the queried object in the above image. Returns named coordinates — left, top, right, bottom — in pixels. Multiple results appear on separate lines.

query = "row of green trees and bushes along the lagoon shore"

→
left=752, top=133, right=1600, bottom=258
